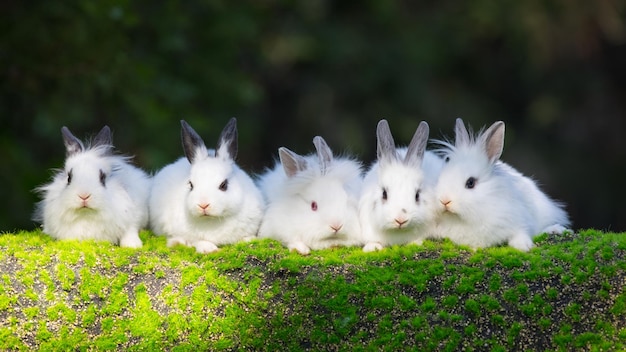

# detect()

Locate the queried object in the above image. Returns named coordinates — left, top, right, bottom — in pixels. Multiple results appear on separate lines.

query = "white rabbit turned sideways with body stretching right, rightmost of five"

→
left=434, top=119, right=570, bottom=251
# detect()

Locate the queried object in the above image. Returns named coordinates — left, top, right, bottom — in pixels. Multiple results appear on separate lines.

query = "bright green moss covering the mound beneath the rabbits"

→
left=0, top=230, right=626, bottom=351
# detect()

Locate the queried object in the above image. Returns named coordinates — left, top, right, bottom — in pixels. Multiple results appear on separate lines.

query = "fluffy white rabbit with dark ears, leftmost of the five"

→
left=35, top=126, right=150, bottom=248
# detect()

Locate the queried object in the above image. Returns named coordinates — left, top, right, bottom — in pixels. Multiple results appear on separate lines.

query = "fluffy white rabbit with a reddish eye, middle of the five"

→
left=259, top=136, right=362, bottom=255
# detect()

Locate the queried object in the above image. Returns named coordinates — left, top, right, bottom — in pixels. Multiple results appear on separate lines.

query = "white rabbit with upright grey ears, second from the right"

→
left=359, top=120, right=443, bottom=252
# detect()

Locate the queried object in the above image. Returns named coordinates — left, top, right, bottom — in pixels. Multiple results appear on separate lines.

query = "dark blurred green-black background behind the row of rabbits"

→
left=0, top=0, right=626, bottom=231
